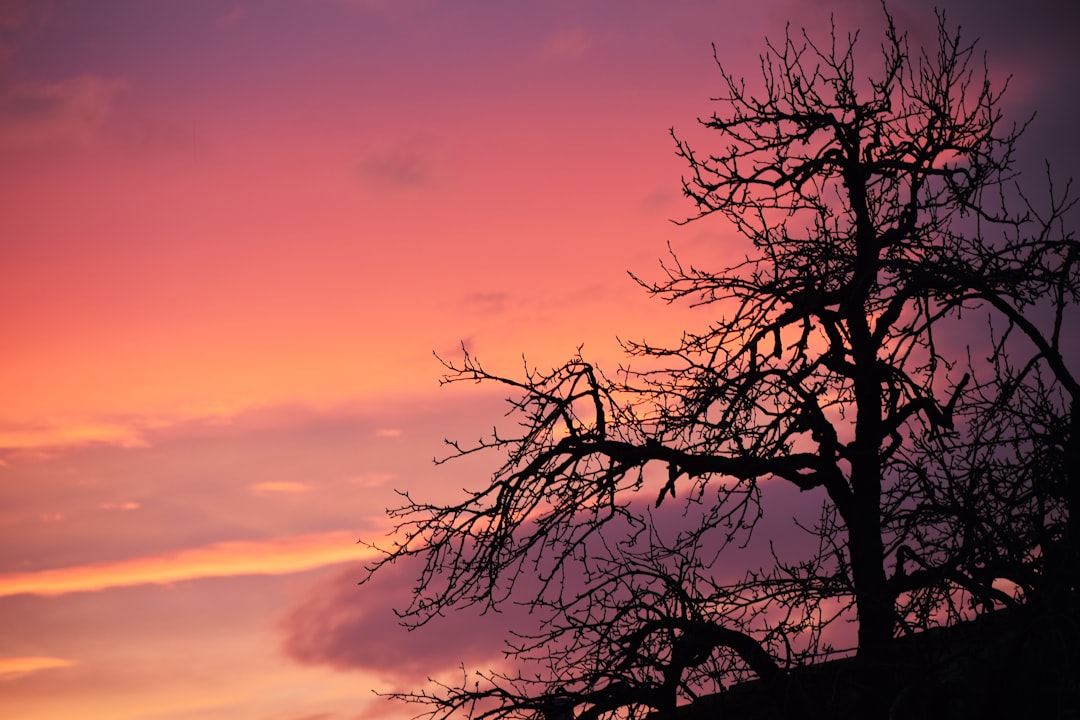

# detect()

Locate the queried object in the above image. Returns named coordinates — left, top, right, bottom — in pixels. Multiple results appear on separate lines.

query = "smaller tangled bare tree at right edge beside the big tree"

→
left=892, top=173, right=1080, bottom=616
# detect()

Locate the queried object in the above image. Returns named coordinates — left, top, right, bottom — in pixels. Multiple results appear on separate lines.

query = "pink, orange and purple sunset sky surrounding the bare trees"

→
left=0, top=0, right=1080, bottom=720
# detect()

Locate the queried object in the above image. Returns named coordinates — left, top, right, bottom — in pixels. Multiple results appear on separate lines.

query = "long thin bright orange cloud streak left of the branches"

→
left=0, top=531, right=372, bottom=597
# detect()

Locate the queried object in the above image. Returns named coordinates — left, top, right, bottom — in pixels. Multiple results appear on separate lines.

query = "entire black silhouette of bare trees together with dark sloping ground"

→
left=360, top=11, right=1080, bottom=720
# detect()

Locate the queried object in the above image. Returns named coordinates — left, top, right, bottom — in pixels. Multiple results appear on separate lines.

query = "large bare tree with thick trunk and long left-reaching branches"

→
left=360, top=7, right=1076, bottom=720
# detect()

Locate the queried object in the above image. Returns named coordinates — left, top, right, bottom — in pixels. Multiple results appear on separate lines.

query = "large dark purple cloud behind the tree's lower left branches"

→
left=280, top=483, right=833, bottom=683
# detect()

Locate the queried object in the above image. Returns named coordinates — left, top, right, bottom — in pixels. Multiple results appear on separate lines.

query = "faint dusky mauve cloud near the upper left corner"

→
left=0, top=73, right=124, bottom=145
